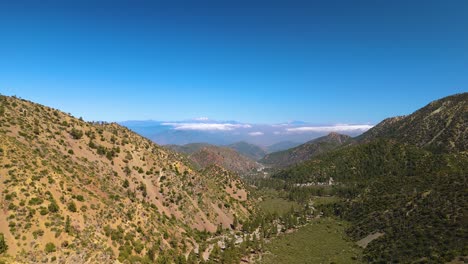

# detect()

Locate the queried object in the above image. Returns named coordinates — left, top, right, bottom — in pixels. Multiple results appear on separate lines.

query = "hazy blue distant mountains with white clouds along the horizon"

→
left=120, top=119, right=373, bottom=146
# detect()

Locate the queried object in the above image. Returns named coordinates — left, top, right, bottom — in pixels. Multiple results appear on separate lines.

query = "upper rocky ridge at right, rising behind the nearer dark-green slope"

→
left=359, top=93, right=468, bottom=153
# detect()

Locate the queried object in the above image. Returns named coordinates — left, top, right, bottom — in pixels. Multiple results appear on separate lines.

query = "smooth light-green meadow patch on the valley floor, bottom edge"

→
left=261, top=218, right=362, bottom=264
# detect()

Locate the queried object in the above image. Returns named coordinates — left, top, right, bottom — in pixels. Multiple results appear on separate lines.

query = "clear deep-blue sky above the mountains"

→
left=0, top=0, right=468, bottom=123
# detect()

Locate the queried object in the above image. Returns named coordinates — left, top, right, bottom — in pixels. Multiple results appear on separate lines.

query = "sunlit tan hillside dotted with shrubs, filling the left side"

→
left=0, top=96, right=252, bottom=263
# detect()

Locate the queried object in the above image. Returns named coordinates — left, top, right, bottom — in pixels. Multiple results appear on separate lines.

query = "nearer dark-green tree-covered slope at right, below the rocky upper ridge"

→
left=274, top=140, right=468, bottom=263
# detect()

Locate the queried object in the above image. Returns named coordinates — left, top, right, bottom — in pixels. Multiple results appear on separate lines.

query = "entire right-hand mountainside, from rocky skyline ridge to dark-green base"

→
left=273, top=94, right=468, bottom=263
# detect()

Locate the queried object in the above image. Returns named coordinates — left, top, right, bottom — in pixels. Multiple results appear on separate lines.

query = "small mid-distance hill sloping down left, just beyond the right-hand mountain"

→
left=260, top=133, right=352, bottom=167
